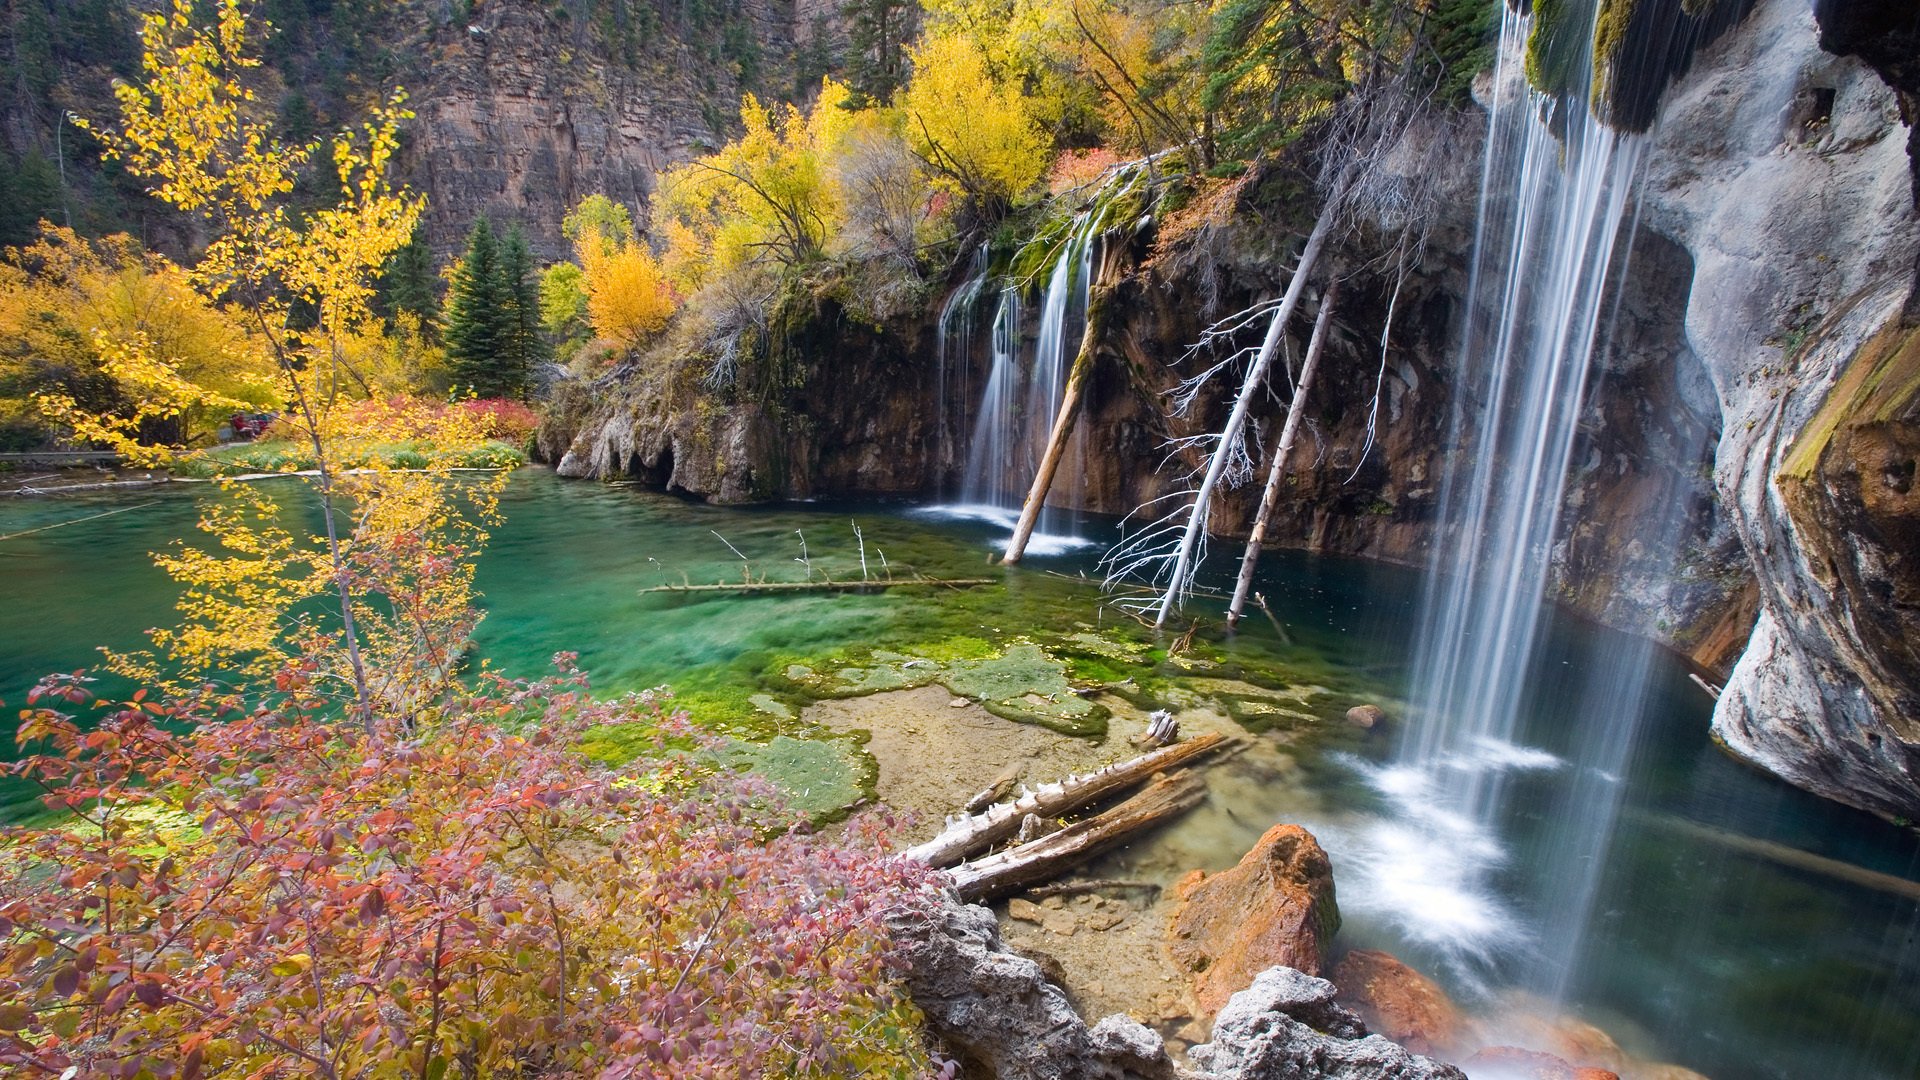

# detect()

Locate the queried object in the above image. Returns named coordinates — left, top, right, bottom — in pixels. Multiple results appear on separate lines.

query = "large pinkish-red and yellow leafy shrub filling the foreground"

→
left=0, top=657, right=931, bottom=1080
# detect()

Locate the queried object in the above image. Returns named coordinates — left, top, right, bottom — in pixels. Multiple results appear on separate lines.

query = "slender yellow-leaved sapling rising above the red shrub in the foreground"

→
left=72, top=0, right=497, bottom=732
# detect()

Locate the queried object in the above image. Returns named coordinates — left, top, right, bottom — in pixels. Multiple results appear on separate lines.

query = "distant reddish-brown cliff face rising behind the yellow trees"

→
left=401, top=0, right=793, bottom=259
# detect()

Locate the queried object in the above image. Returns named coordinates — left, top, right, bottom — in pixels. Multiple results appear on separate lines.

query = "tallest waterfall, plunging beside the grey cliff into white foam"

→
left=1357, top=6, right=1672, bottom=997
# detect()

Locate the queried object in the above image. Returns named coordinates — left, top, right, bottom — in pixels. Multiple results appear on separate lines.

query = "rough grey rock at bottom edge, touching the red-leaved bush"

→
left=893, top=896, right=1173, bottom=1080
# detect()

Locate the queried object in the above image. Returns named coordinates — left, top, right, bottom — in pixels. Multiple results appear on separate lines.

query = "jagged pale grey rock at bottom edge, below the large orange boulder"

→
left=1188, top=967, right=1467, bottom=1080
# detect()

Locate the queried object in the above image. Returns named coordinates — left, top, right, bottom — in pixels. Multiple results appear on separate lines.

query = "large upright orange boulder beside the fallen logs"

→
left=1169, top=824, right=1340, bottom=1013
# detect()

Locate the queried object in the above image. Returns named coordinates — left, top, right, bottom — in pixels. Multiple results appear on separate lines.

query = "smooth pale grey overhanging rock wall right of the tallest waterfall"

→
left=1645, top=0, right=1920, bottom=817
